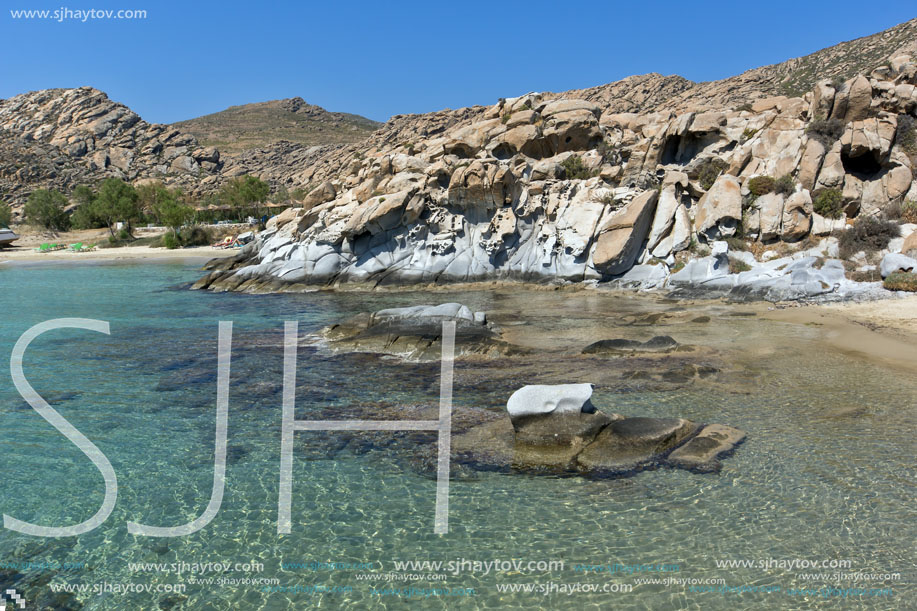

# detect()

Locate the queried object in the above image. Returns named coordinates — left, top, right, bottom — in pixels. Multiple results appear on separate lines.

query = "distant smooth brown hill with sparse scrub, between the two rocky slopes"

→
left=172, top=98, right=382, bottom=155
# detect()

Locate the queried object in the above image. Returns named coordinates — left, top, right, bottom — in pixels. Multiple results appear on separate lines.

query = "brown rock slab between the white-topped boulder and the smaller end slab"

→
left=576, top=418, right=697, bottom=473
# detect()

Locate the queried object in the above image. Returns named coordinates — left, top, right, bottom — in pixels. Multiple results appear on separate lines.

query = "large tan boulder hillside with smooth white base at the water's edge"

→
left=198, top=30, right=917, bottom=297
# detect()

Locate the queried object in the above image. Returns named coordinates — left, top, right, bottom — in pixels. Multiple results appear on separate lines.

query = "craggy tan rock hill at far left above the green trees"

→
left=0, top=87, right=223, bottom=204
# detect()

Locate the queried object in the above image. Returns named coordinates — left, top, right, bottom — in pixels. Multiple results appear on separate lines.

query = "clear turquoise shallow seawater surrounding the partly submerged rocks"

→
left=0, top=262, right=917, bottom=609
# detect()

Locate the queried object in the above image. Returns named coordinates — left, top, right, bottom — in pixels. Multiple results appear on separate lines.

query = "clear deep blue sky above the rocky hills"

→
left=0, top=0, right=917, bottom=123
